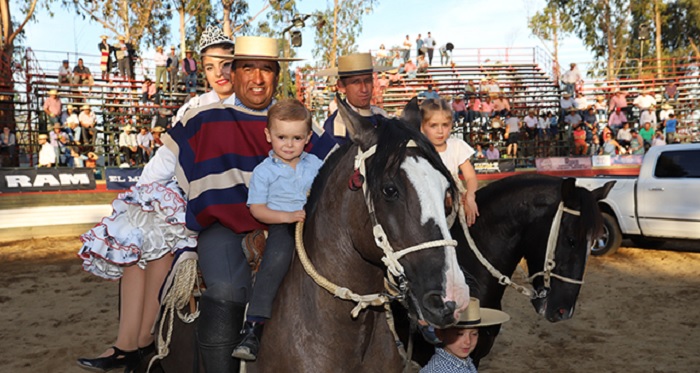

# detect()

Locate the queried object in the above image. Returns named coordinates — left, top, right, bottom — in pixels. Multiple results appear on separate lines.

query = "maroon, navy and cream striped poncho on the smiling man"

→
left=162, top=103, right=271, bottom=233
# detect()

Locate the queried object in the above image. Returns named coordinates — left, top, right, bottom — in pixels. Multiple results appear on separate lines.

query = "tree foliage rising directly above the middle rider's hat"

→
left=313, top=0, right=379, bottom=66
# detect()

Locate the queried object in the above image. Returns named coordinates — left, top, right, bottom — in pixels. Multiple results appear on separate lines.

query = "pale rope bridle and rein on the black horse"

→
left=459, top=196, right=583, bottom=299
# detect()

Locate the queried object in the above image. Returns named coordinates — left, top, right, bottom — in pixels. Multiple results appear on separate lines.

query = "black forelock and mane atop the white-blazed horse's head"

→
left=367, top=119, right=458, bottom=201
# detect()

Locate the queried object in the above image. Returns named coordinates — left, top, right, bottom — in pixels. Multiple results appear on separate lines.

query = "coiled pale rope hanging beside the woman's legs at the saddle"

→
left=146, top=258, right=199, bottom=372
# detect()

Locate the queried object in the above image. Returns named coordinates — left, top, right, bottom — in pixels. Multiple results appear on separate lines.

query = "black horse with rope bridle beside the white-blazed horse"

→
left=394, top=174, right=614, bottom=366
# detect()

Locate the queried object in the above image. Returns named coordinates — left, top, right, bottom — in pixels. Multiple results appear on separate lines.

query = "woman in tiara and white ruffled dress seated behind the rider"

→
left=78, top=26, right=233, bottom=372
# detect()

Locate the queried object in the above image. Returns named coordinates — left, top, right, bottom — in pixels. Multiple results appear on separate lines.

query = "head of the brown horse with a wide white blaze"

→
left=326, top=97, right=469, bottom=327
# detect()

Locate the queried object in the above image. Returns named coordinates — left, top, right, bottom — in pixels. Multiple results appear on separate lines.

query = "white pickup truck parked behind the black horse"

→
left=576, top=144, right=700, bottom=255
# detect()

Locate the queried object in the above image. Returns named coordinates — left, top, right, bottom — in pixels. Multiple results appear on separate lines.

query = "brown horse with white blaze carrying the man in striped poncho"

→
left=241, top=96, right=469, bottom=372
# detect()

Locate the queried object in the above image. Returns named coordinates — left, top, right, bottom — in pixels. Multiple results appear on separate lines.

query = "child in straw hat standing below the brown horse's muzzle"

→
left=420, top=298, right=510, bottom=373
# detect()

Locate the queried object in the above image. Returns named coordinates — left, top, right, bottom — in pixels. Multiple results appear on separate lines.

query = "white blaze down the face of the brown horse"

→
left=401, top=157, right=469, bottom=319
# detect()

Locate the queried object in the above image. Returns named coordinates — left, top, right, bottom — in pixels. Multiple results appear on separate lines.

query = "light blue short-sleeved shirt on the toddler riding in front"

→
left=248, top=151, right=323, bottom=212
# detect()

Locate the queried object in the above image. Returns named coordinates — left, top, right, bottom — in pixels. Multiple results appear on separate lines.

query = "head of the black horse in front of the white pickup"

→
left=526, top=178, right=614, bottom=322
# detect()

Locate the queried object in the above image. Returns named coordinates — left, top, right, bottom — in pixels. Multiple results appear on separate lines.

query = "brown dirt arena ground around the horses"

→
left=0, top=237, right=700, bottom=373
